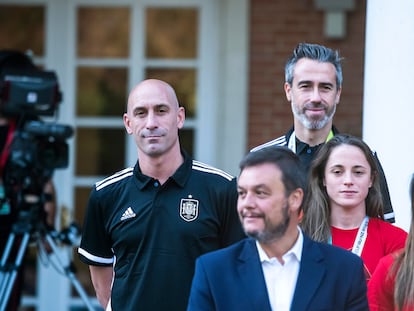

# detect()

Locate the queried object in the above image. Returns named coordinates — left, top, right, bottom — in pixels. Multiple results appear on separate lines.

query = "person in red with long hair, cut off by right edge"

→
left=368, top=174, right=414, bottom=311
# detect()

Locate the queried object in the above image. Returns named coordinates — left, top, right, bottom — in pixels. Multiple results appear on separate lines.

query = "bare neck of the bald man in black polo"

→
left=138, top=148, right=184, bottom=184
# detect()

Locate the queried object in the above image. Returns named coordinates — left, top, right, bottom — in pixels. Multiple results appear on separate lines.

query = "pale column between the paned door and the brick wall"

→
left=215, top=0, right=250, bottom=176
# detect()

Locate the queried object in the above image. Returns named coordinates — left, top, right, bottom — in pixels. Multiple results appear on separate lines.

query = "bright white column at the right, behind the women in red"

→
left=363, top=0, right=414, bottom=230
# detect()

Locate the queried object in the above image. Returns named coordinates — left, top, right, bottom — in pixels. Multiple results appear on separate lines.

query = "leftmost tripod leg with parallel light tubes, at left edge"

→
left=0, top=232, right=30, bottom=311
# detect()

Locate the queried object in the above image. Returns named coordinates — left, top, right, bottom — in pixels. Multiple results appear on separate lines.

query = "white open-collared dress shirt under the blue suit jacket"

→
left=256, top=228, right=303, bottom=311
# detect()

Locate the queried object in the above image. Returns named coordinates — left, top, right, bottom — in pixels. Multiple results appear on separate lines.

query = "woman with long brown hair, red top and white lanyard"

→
left=301, top=135, right=407, bottom=281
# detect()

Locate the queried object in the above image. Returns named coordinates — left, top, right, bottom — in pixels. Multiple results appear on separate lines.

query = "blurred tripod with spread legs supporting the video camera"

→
left=0, top=209, right=95, bottom=311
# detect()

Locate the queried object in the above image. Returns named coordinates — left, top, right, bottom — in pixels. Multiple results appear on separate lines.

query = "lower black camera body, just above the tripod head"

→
left=3, top=121, right=72, bottom=209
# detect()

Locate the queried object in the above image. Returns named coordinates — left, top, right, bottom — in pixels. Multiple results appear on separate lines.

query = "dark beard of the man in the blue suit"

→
left=246, top=202, right=290, bottom=243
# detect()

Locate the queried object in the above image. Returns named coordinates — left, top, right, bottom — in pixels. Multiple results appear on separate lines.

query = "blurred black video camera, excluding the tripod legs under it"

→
left=0, top=51, right=73, bottom=216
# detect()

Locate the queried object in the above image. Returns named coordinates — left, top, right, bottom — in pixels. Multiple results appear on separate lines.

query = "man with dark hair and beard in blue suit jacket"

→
left=188, top=147, right=368, bottom=311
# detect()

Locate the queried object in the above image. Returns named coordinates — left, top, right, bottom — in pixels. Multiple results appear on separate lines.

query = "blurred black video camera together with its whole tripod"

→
left=0, top=51, right=94, bottom=311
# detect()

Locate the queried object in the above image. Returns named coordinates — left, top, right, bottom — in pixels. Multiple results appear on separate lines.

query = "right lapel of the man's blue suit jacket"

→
left=291, top=236, right=326, bottom=310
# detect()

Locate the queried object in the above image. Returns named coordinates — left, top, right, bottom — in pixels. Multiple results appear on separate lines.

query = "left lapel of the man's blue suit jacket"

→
left=237, top=238, right=271, bottom=311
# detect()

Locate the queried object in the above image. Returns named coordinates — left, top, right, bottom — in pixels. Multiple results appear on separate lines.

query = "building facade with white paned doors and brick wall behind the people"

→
left=0, top=0, right=408, bottom=310
